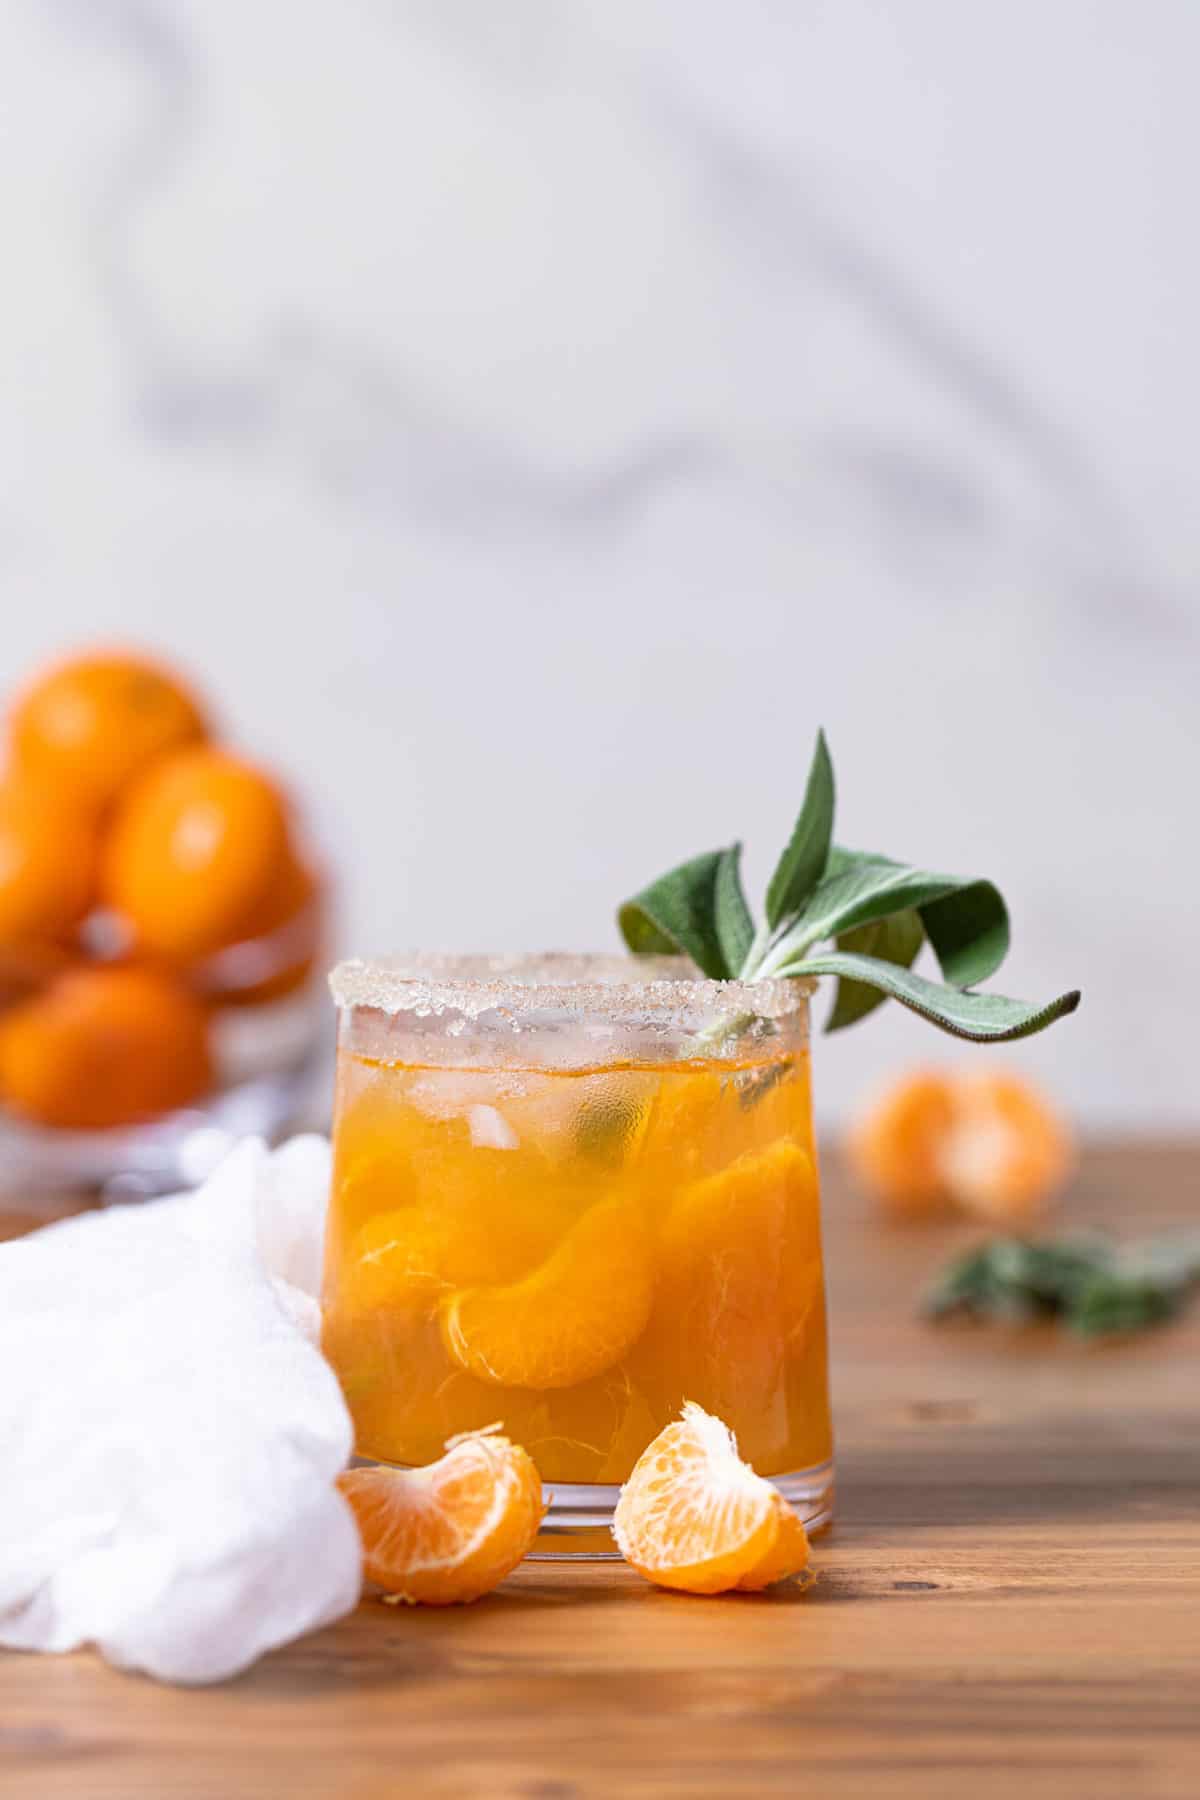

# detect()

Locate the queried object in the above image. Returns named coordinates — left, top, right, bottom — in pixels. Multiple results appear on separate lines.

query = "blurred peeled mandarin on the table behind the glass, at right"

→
left=847, top=1069, right=1074, bottom=1220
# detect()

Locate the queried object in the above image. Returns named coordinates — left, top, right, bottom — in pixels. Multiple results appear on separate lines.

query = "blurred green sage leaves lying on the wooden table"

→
left=925, top=1231, right=1200, bottom=1337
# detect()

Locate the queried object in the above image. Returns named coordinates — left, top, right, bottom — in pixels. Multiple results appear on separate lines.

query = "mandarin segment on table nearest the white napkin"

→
left=338, top=1429, right=545, bottom=1606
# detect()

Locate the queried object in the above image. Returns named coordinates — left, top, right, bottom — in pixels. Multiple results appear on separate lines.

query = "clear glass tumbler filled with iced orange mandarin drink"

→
left=324, top=956, right=833, bottom=1555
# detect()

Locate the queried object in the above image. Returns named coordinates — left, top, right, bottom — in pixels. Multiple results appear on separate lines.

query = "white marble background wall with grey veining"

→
left=0, top=0, right=1200, bottom=1130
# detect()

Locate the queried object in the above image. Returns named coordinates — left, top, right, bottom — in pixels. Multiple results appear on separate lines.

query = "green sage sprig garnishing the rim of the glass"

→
left=617, top=733, right=1079, bottom=1042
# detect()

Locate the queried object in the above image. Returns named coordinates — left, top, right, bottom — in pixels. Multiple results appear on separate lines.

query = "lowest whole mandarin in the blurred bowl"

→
left=0, top=967, right=212, bottom=1130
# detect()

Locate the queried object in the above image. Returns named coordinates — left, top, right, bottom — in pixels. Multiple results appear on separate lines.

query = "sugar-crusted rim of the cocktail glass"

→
left=329, top=950, right=817, bottom=1019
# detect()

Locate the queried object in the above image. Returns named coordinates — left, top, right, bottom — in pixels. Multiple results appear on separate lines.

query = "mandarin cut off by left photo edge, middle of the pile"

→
left=0, top=774, right=99, bottom=945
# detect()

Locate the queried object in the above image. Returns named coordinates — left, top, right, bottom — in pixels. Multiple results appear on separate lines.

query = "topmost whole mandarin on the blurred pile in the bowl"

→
left=11, top=652, right=207, bottom=808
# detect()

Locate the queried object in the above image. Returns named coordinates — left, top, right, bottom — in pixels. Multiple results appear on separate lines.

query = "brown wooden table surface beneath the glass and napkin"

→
left=0, top=1148, right=1200, bottom=1800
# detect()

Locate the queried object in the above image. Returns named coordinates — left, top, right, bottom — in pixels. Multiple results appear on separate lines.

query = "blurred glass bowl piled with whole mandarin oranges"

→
left=0, top=652, right=329, bottom=1199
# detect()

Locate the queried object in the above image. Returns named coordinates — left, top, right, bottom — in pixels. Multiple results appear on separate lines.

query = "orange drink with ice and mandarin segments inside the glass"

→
left=324, top=1051, right=831, bottom=1483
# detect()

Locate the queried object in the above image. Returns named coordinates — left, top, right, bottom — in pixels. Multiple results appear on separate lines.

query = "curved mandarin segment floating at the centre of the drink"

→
left=441, top=1201, right=653, bottom=1388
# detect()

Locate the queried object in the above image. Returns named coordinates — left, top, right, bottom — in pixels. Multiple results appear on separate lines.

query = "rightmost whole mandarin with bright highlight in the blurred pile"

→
left=101, top=747, right=290, bottom=961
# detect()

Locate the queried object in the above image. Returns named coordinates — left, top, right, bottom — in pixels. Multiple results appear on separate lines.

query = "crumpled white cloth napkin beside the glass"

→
left=0, top=1138, right=362, bottom=1681
